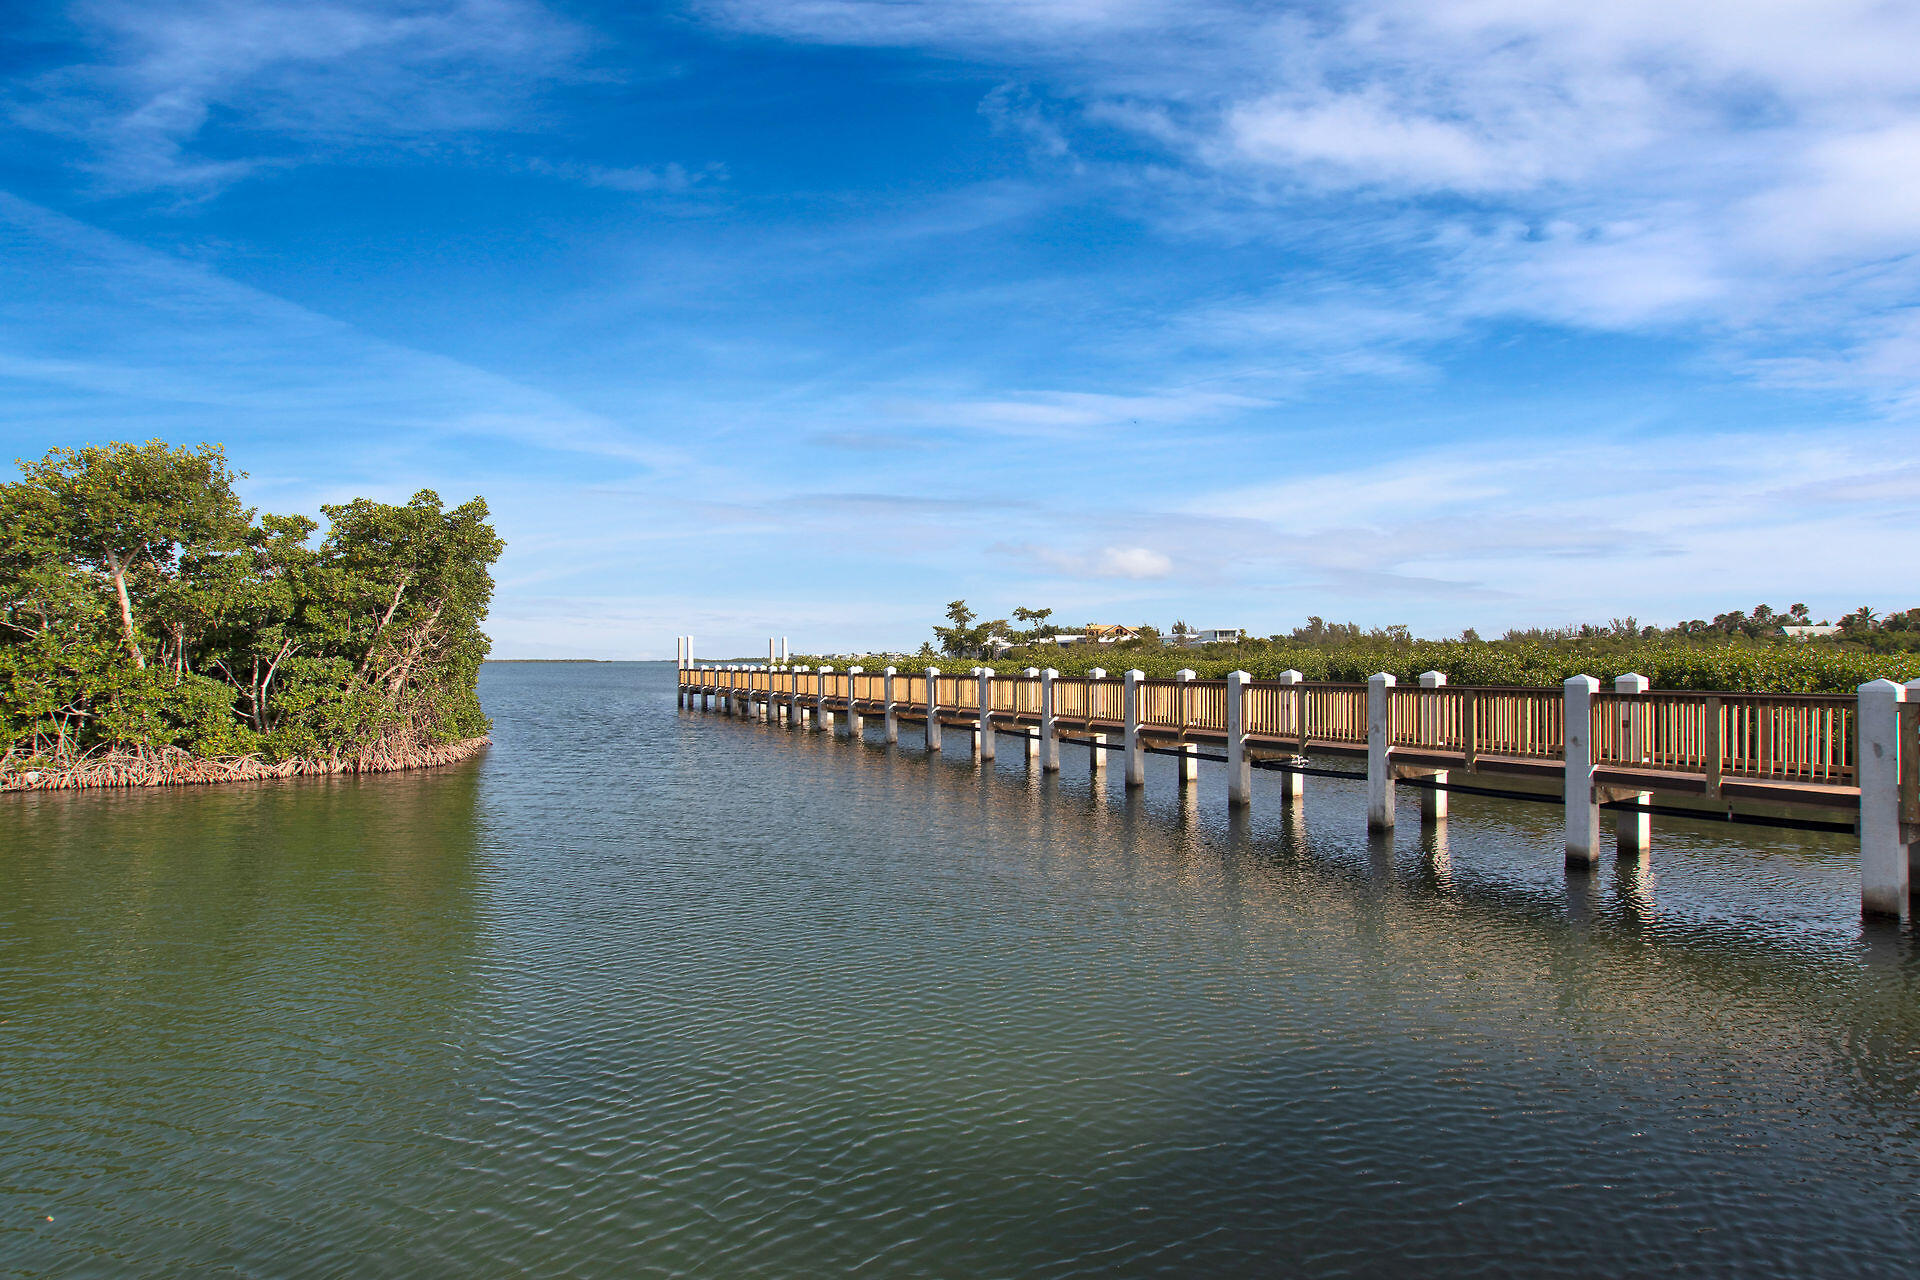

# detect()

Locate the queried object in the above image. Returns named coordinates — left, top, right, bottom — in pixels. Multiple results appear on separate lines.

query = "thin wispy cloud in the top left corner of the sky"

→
left=0, top=0, right=586, bottom=198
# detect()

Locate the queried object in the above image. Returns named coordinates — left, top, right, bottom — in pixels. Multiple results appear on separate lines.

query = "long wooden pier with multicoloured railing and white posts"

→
left=680, top=656, right=1920, bottom=915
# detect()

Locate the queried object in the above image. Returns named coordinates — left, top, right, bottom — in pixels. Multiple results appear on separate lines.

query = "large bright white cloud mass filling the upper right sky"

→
left=708, top=0, right=1920, bottom=416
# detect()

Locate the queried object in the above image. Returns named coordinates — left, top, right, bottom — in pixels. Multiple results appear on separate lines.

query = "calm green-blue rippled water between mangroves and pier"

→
left=0, top=666, right=1920, bottom=1276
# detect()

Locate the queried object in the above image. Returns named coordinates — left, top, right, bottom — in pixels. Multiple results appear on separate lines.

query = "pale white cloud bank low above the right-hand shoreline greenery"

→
left=1183, top=428, right=1920, bottom=620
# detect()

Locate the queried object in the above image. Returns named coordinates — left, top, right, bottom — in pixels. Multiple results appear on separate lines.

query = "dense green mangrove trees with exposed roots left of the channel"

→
left=0, top=441, right=503, bottom=768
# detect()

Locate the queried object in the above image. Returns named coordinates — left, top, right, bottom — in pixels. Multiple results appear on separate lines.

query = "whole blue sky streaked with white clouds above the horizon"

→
left=0, top=0, right=1920, bottom=656
